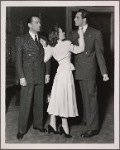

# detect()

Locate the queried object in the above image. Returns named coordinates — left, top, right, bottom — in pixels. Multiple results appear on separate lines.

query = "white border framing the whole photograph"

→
left=1, top=1, right=120, bottom=149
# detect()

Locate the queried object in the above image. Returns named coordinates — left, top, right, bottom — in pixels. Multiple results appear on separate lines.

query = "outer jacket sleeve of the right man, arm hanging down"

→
left=95, top=31, right=107, bottom=75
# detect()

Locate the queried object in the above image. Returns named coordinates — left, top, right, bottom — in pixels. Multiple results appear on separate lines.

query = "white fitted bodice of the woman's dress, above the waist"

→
left=44, top=41, right=81, bottom=70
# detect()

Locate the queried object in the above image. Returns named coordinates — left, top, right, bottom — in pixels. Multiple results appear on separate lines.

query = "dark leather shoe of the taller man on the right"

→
left=81, top=130, right=99, bottom=138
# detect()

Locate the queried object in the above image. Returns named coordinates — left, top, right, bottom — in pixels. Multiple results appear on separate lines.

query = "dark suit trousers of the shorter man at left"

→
left=18, top=84, right=44, bottom=134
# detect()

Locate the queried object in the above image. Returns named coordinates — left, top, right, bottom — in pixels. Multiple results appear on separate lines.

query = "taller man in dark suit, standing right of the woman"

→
left=70, top=9, right=109, bottom=138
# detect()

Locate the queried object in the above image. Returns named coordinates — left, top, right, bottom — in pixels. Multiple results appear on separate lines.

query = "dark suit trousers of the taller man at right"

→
left=79, top=80, right=99, bottom=130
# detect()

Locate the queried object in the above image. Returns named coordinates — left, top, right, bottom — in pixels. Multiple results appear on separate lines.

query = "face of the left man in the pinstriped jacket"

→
left=28, top=17, right=41, bottom=32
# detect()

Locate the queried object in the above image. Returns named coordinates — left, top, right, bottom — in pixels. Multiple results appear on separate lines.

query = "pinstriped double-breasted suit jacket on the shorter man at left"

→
left=16, top=33, right=50, bottom=84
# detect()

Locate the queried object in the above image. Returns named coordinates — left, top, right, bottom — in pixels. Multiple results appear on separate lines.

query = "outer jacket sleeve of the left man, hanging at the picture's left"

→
left=15, top=37, right=25, bottom=79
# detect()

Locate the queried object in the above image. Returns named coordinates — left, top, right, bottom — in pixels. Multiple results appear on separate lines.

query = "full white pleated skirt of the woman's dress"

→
left=47, top=63, right=78, bottom=118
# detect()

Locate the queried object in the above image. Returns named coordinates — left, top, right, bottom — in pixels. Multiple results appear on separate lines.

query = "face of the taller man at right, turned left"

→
left=74, top=12, right=85, bottom=26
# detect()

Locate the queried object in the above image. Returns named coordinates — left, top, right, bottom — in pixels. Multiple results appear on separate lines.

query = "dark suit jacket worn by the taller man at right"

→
left=70, top=27, right=107, bottom=80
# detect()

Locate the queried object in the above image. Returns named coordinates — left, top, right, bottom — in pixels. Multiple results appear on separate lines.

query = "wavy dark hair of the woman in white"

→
left=49, top=26, right=59, bottom=47
